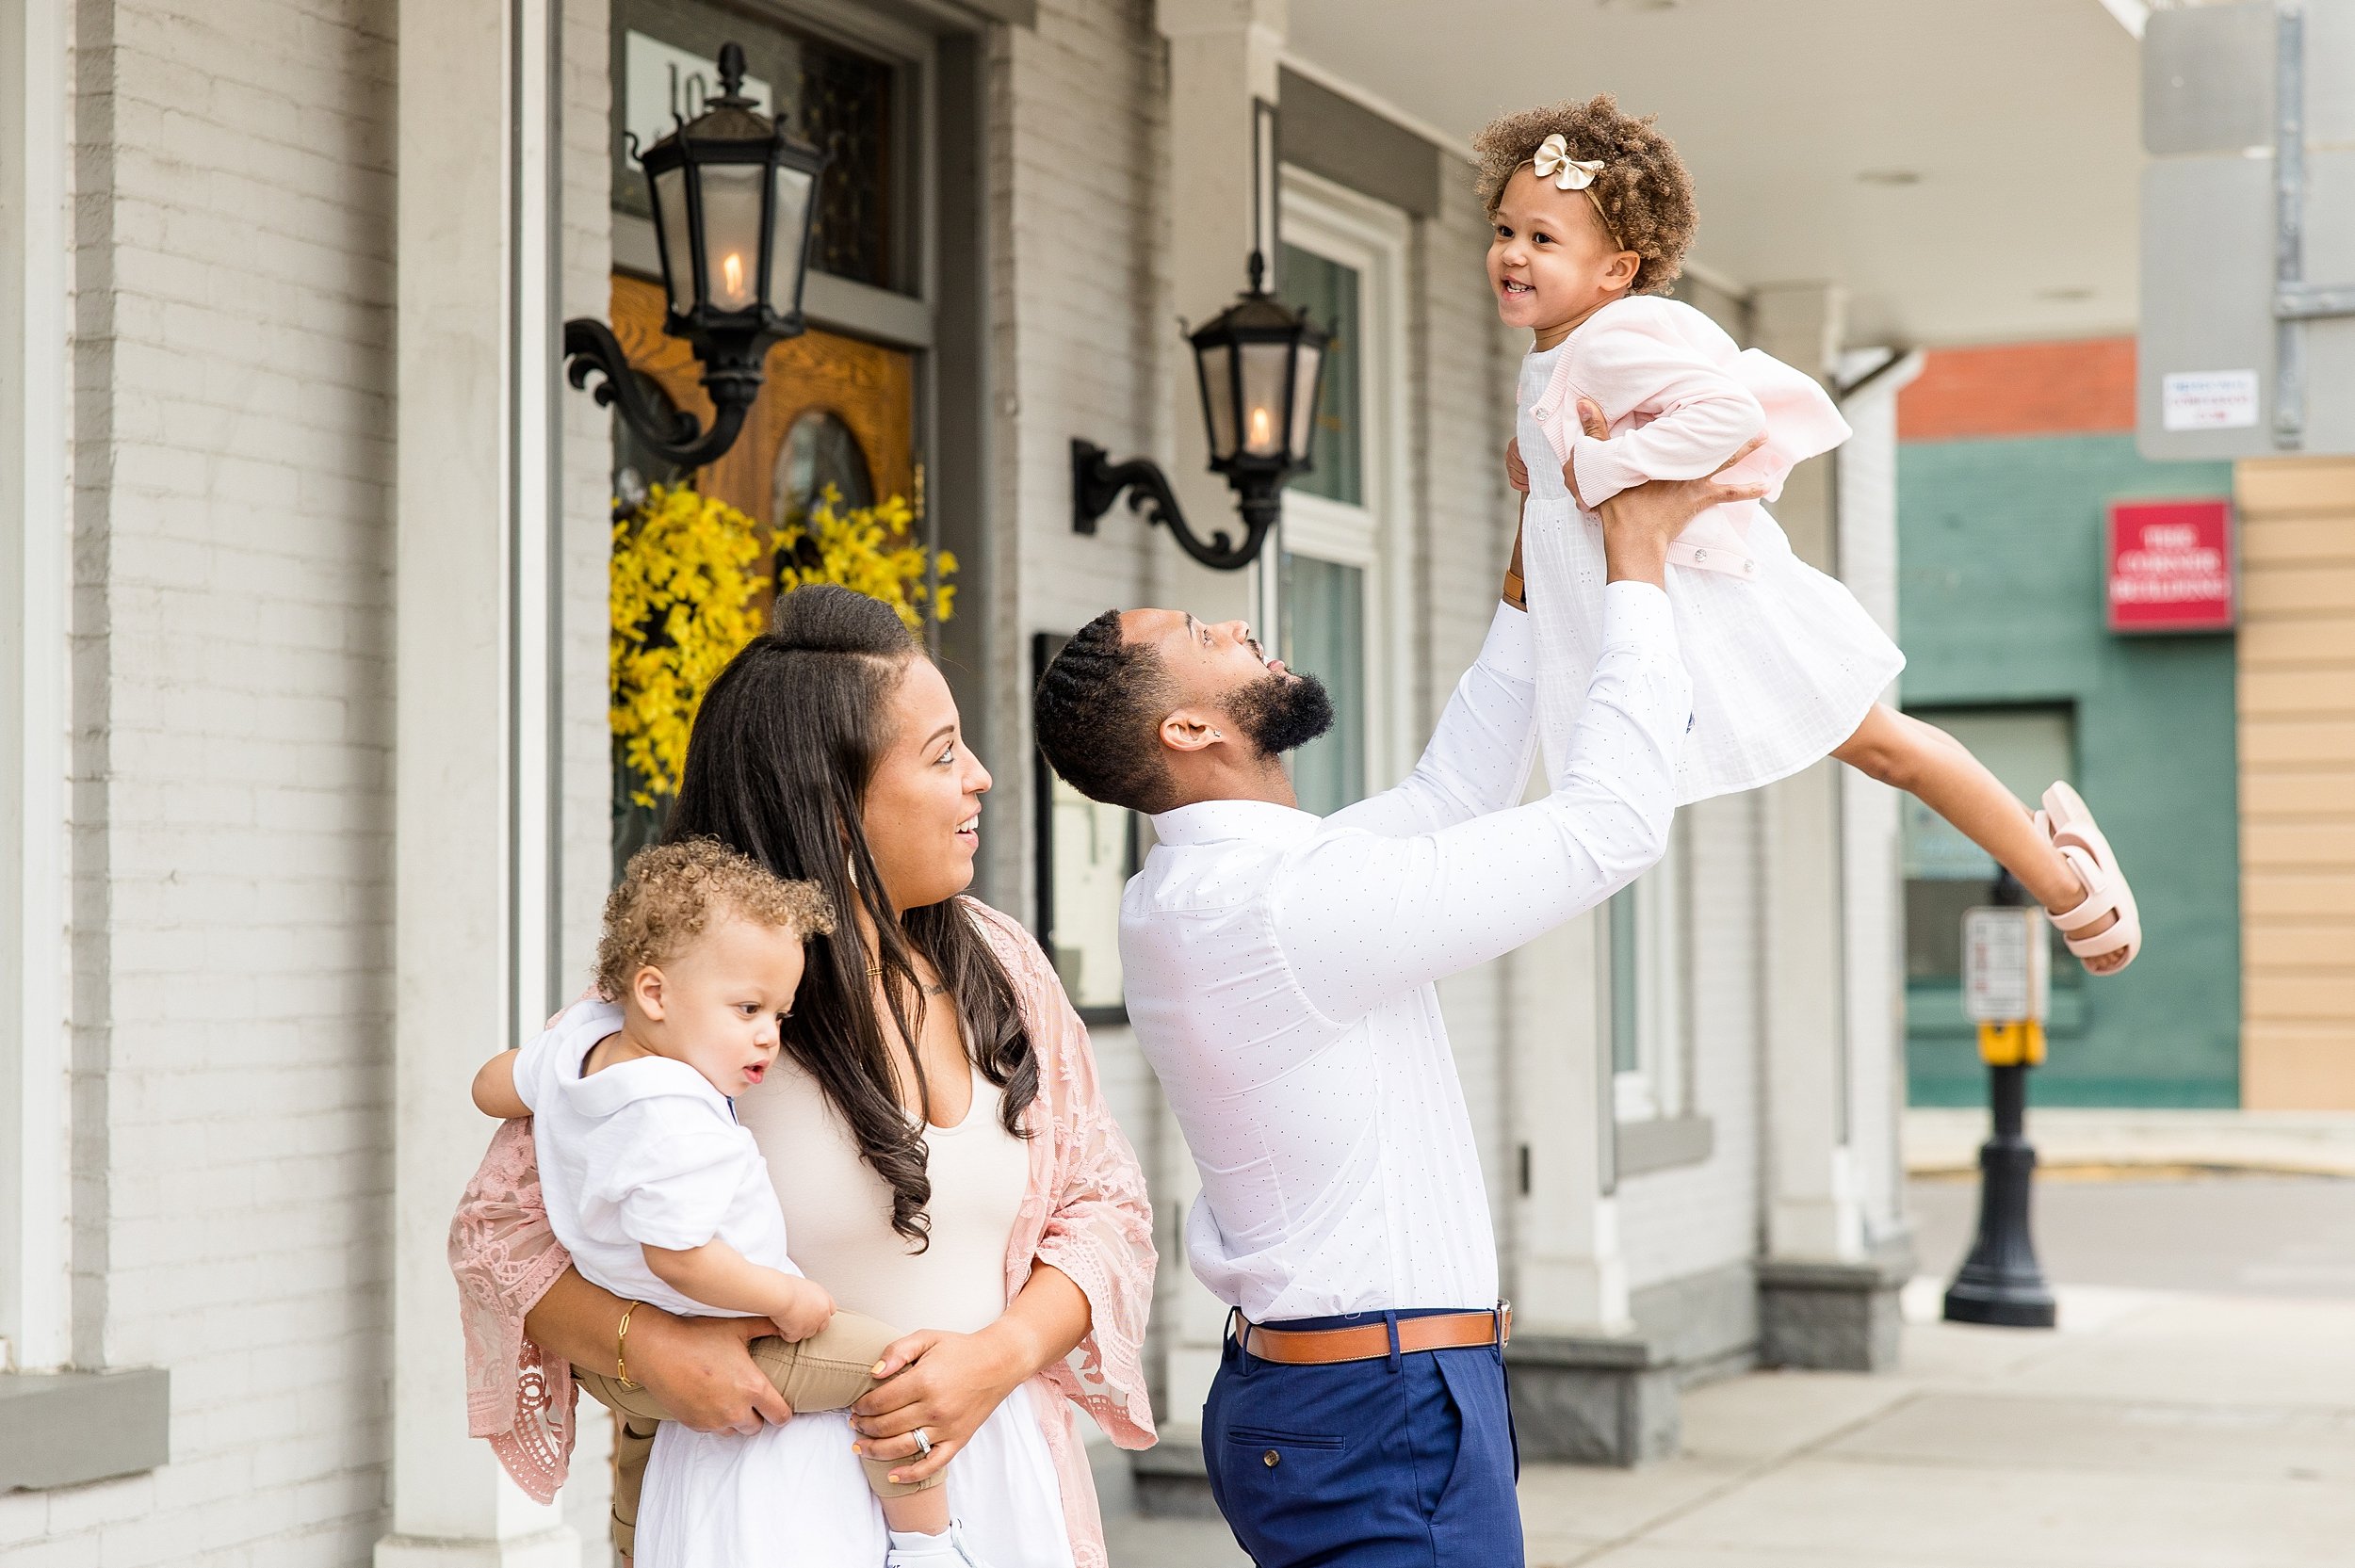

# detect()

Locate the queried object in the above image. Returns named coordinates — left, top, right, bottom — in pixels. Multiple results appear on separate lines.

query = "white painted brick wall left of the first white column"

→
left=0, top=0, right=394, bottom=1568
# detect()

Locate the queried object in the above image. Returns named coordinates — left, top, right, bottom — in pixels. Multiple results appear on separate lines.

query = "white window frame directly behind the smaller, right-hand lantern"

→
left=1262, top=168, right=1416, bottom=794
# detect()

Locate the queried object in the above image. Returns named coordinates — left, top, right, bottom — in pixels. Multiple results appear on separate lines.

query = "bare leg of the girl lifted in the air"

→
left=1832, top=702, right=2127, bottom=975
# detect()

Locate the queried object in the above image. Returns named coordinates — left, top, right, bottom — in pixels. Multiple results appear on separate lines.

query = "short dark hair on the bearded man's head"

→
left=1031, top=610, right=1173, bottom=815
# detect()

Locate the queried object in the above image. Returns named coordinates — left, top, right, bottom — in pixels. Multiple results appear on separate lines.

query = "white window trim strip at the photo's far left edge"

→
left=0, top=0, right=71, bottom=1370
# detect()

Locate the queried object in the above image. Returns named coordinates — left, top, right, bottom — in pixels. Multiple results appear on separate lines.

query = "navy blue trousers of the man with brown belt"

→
left=1201, top=1312, right=1521, bottom=1568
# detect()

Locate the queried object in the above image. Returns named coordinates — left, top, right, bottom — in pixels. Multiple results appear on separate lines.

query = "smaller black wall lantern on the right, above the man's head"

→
left=1072, top=104, right=1333, bottom=573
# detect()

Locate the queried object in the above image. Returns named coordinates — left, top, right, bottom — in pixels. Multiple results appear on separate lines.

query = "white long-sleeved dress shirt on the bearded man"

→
left=1121, top=584, right=1691, bottom=1323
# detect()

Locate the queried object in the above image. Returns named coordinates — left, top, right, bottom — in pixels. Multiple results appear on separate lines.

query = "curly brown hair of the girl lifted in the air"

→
left=1472, top=92, right=1698, bottom=295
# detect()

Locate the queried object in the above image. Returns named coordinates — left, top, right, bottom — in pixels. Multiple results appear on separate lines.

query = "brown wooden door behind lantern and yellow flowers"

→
left=612, top=273, right=917, bottom=527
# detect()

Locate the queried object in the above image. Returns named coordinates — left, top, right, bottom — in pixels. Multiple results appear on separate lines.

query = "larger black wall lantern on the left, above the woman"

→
left=565, top=42, right=827, bottom=469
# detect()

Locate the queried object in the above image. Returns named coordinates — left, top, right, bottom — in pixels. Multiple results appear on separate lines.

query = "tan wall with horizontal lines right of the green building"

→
left=2235, top=460, right=2355, bottom=1109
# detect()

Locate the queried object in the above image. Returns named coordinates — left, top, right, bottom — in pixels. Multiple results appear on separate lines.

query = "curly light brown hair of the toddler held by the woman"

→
left=596, top=838, right=834, bottom=1001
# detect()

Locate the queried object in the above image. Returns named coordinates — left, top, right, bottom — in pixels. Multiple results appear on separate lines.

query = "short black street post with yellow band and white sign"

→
left=1945, top=899, right=2056, bottom=1328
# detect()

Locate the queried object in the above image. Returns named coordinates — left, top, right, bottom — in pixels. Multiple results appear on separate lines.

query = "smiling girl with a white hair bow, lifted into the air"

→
left=1472, top=94, right=2143, bottom=975
